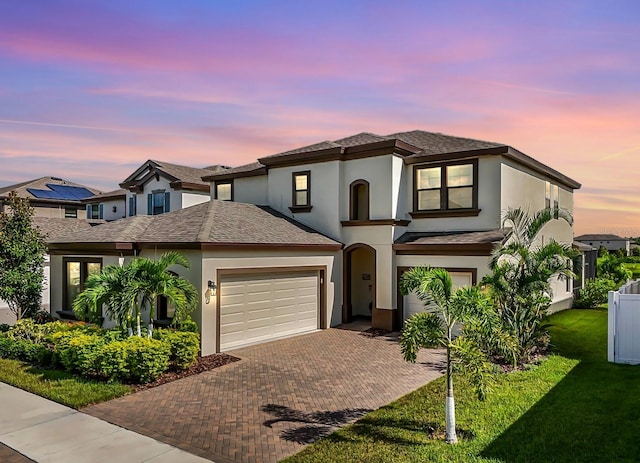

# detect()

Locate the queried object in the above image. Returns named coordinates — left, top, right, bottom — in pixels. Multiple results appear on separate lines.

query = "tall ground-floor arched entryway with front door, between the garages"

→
left=342, top=243, right=376, bottom=323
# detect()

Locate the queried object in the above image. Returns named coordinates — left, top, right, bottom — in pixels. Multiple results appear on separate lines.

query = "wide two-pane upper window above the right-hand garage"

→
left=414, top=161, right=478, bottom=212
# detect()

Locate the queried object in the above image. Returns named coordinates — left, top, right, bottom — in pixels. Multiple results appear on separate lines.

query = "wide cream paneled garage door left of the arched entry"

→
left=219, top=271, right=320, bottom=352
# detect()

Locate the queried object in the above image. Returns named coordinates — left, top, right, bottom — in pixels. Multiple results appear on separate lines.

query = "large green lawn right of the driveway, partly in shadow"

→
left=285, top=309, right=640, bottom=463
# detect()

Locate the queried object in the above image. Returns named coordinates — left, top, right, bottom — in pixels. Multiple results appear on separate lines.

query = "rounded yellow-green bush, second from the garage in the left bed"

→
left=123, top=336, right=171, bottom=383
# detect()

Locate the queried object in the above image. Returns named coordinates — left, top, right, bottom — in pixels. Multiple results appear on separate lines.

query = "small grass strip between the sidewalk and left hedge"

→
left=0, top=358, right=131, bottom=408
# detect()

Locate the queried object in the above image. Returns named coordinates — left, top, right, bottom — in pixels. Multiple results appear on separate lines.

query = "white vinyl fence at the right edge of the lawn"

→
left=608, top=280, right=640, bottom=365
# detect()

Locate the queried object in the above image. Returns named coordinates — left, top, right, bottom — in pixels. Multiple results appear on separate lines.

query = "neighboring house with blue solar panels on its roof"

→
left=0, top=177, right=100, bottom=219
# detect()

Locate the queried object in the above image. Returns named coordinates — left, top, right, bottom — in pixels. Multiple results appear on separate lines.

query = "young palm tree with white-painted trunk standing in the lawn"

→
left=400, top=267, right=513, bottom=443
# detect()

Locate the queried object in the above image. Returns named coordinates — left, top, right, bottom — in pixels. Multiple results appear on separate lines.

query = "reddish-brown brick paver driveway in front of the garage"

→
left=83, top=329, right=443, bottom=463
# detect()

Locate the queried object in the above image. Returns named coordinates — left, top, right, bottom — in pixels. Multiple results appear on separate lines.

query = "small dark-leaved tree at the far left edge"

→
left=0, top=191, right=47, bottom=320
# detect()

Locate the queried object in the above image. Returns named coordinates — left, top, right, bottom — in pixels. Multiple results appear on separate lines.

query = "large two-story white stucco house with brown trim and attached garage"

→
left=51, top=131, right=580, bottom=355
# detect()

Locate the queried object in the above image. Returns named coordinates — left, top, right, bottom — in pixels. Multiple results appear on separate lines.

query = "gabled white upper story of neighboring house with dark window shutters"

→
left=120, top=160, right=226, bottom=217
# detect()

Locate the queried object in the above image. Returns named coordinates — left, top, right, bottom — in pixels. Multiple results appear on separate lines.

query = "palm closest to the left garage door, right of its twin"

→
left=131, top=251, right=198, bottom=337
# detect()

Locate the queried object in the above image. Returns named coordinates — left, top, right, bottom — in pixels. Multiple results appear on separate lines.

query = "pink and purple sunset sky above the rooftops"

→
left=0, top=0, right=640, bottom=236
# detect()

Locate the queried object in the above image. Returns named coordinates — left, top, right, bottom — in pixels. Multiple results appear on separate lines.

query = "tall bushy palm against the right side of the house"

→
left=482, top=208, right=574, bottom=361
